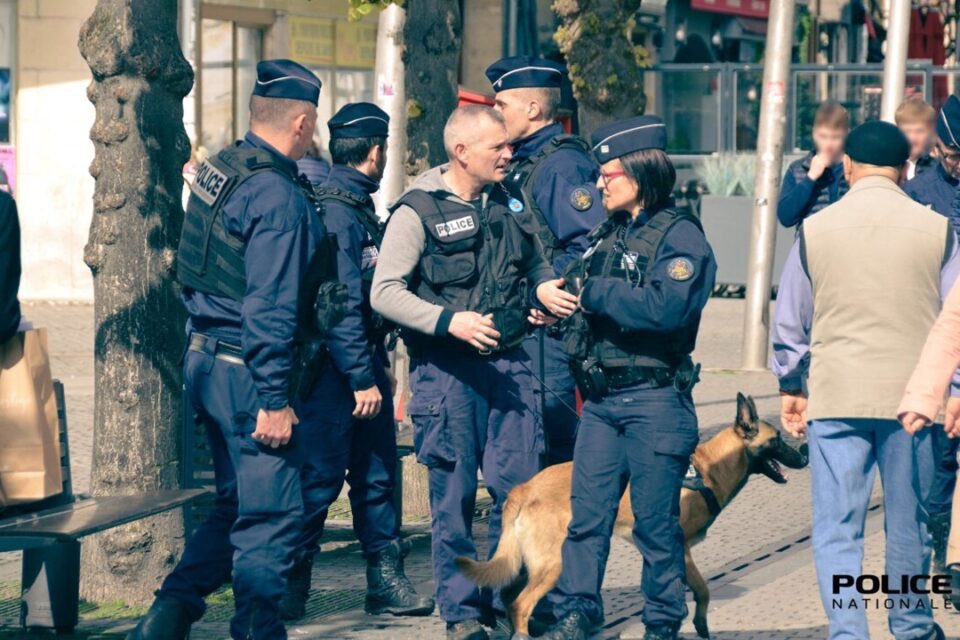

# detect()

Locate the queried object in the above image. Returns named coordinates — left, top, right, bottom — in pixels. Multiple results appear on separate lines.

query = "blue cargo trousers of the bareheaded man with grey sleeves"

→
left=408, top=347, right=543, bottom=622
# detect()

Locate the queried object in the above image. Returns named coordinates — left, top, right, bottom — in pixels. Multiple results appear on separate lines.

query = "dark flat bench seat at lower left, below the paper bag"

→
left=0, top=489, right=207, bottom=546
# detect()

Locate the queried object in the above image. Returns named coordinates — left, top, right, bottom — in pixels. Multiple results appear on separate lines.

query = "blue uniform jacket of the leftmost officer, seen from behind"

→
left=183, top=133, right=320, bottom=410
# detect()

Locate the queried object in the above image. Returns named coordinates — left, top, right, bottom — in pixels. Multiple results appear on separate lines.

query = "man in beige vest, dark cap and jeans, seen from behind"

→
left=772, top=122, right=960, bottom=640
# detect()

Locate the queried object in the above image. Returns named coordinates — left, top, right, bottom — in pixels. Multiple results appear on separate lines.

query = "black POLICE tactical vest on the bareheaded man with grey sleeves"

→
left=391, top=189, right=536, bottom=351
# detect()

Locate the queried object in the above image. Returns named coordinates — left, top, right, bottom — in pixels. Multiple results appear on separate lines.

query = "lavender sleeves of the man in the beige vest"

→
left=770, top=229, right=960, bottom=396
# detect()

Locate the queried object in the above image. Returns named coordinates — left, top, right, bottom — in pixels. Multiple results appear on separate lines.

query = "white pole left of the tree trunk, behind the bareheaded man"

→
left=374, top=4, right=407, bottom=219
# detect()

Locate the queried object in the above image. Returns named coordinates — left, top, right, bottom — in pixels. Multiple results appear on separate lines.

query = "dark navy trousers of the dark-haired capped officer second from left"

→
left=297, top=359, right=398, bottom=555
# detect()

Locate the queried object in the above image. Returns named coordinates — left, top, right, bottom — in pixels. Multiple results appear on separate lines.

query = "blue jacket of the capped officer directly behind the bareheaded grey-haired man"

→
left=513, top=124, right=606, bottom=274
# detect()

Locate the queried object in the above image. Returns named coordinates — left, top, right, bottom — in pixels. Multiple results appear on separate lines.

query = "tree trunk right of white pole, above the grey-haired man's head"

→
left=403, top=0, right=463, bottom=176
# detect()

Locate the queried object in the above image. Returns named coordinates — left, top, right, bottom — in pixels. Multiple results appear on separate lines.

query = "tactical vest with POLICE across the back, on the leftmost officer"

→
left=177, top=146, right=297, bottom=301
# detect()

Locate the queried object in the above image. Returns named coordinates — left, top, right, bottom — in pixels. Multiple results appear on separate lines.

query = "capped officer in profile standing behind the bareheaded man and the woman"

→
left=486, top=56, right=606, bottom=465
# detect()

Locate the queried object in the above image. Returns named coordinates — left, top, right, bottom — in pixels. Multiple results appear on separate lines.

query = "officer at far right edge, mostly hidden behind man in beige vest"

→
left=903, top=96, right=960, bottom=573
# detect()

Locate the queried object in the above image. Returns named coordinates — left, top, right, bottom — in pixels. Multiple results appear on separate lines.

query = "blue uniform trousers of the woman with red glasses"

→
left=548, top=385, right=699, bottom=625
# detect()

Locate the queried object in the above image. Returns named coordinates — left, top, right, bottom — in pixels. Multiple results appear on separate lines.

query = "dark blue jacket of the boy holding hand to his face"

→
left=777, top=151, right=849, bottom=227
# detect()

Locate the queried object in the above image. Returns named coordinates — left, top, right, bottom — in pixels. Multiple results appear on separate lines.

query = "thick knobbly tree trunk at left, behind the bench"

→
left=80, top=0, right=193, bottom=604
